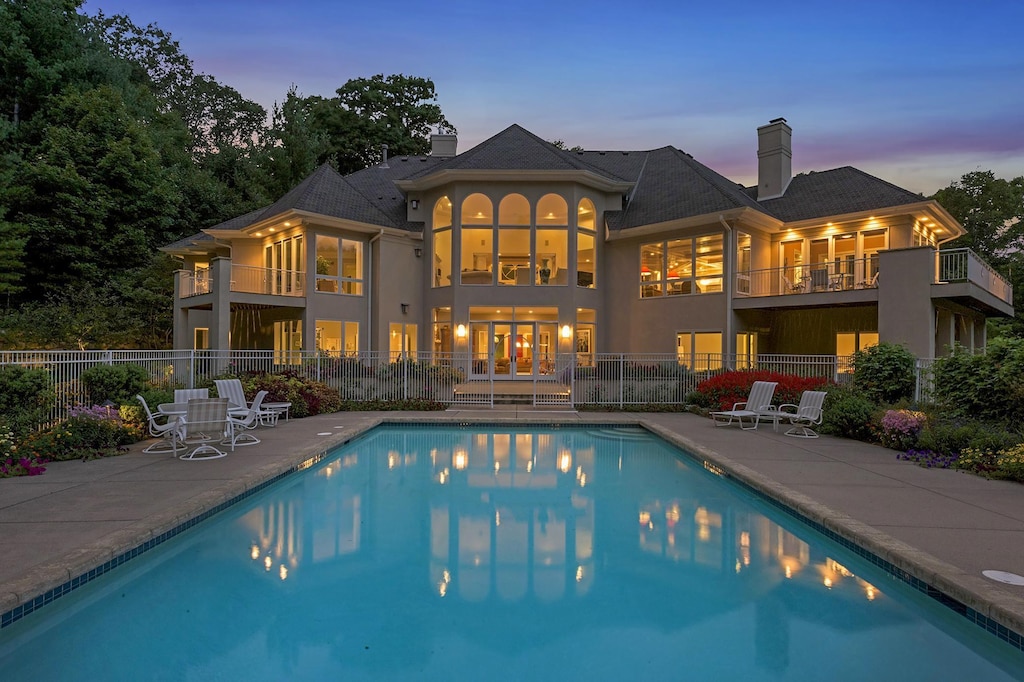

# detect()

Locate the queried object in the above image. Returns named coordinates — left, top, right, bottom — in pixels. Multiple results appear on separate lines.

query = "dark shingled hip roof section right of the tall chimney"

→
left=745, top=166, right=926, bottom=222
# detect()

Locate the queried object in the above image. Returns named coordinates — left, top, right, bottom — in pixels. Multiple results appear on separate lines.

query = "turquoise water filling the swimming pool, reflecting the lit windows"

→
left=0, top=427, right=1024, bottom=682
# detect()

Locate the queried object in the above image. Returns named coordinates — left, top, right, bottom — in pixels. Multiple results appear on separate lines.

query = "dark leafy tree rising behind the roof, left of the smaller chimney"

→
left=312, top=74, right=455, bottom=173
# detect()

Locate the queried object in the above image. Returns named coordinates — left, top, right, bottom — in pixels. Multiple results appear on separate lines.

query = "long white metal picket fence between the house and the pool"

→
left=0, top=350, right=932, bottom=421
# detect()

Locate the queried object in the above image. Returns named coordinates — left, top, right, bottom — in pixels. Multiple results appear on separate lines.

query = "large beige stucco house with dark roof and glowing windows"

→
left=164, top=119, right=1013, bottom=379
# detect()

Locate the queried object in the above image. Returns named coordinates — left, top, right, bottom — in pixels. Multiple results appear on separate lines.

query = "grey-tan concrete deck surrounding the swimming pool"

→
left=0, top=406, right=1024, bottom=634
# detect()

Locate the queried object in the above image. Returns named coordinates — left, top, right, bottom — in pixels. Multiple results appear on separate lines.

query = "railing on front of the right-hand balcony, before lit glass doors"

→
left=735, top=256, right=879, bottom=296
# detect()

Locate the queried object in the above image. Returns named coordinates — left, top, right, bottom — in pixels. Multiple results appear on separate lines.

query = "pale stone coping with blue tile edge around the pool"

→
left=0, top=415, right=1024, bottom=650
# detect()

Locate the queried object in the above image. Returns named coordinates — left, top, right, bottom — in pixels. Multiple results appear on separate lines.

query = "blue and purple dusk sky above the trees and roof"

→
left=84, top=0, right=1024, bottom=195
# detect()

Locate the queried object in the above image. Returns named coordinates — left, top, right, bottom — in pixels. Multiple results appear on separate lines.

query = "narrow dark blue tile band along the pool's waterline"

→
left=0, top=418, right=1024, bottom=651
